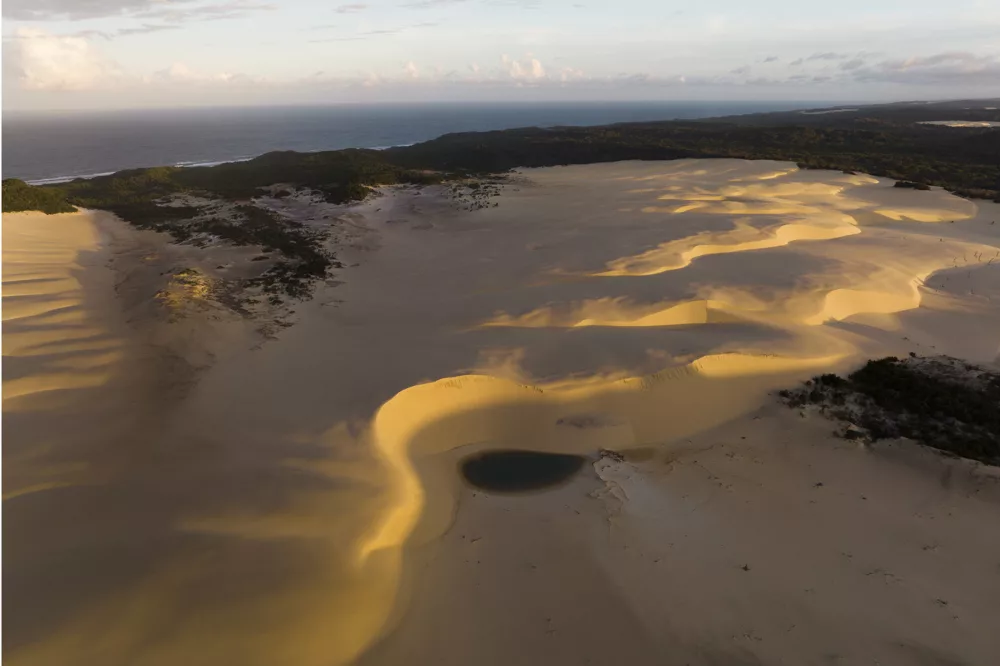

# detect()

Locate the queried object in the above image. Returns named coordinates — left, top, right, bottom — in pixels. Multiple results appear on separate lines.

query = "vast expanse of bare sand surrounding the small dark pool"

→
left=4, top=160, right=1000, bottom=666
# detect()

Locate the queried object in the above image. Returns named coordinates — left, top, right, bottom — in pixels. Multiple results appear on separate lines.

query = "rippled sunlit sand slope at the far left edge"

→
left=3, top=212, right=134, bottom=498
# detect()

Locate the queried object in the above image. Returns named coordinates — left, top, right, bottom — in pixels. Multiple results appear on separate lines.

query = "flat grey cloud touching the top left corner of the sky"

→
left=3, top=0, right=276, bottom=22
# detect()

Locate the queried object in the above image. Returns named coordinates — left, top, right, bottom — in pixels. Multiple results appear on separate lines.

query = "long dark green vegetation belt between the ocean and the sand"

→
left=17, top=97, right=1000, bottom=295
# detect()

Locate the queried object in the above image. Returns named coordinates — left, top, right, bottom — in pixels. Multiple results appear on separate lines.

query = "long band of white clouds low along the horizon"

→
left=4, top=24, right=1000, bottom=100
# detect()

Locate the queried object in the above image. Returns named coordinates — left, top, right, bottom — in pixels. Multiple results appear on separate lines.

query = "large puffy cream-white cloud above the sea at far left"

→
left=4, top=27, right=123, bottom=90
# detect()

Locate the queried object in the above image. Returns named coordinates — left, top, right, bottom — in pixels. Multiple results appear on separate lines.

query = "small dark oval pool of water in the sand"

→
left=461, top=450, right=587, bottom=493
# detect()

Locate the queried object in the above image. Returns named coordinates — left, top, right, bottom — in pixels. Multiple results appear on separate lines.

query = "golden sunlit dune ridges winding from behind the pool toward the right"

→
left=359, top=161, right=997, bottom=660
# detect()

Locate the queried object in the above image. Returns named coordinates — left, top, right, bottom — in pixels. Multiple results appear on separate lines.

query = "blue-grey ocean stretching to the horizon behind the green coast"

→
left=3, top=102, right=823, bottom=184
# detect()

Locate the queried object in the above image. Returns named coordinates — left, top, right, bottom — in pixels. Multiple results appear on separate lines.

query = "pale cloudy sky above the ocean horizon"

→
left=3, top=0, right=1000, bottom=111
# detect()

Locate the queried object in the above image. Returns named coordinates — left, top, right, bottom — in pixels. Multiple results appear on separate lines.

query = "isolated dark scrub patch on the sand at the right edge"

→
left=779, top=356, right=1000, bottom=465
